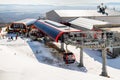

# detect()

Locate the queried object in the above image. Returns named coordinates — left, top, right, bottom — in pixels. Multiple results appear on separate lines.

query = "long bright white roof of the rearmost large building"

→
left=55, top=10, right=120, bottom=17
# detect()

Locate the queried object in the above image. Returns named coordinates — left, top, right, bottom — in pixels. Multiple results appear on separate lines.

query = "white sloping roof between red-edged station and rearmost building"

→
left=70, top=18, right=109, bottom=30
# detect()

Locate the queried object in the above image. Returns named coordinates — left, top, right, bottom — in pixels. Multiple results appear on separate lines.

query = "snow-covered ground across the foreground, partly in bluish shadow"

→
left=0, top=34, right=120, bottom=80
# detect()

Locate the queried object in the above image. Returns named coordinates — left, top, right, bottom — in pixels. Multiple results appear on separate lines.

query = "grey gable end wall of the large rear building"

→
left=46, top=10, right=62, bottom=22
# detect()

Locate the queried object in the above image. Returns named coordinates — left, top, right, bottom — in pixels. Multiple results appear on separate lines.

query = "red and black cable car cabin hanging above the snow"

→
left=63, top=52, right=75, bottom=64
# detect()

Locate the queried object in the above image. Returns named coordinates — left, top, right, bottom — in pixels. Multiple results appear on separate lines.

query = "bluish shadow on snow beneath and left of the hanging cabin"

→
left=27, top=41, right=87, bottom=73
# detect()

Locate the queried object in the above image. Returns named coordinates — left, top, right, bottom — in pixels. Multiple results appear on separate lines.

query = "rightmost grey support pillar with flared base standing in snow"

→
left=101, top=49, right=109, bottom=77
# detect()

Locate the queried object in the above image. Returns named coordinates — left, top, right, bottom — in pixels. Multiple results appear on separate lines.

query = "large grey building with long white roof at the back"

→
left=46, top=10, right=120, bottom=22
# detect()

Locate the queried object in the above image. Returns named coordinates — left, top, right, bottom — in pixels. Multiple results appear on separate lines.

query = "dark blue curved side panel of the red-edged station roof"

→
left=34, top=21, right=61, bottom=39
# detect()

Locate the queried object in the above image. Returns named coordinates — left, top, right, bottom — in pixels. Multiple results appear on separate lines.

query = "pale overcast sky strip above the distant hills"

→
left=0, top=0, right=120, bottom=5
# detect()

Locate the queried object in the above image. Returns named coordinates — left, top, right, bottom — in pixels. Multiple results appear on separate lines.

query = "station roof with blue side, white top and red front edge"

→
left=34, top=20, right=80, bottom=42
